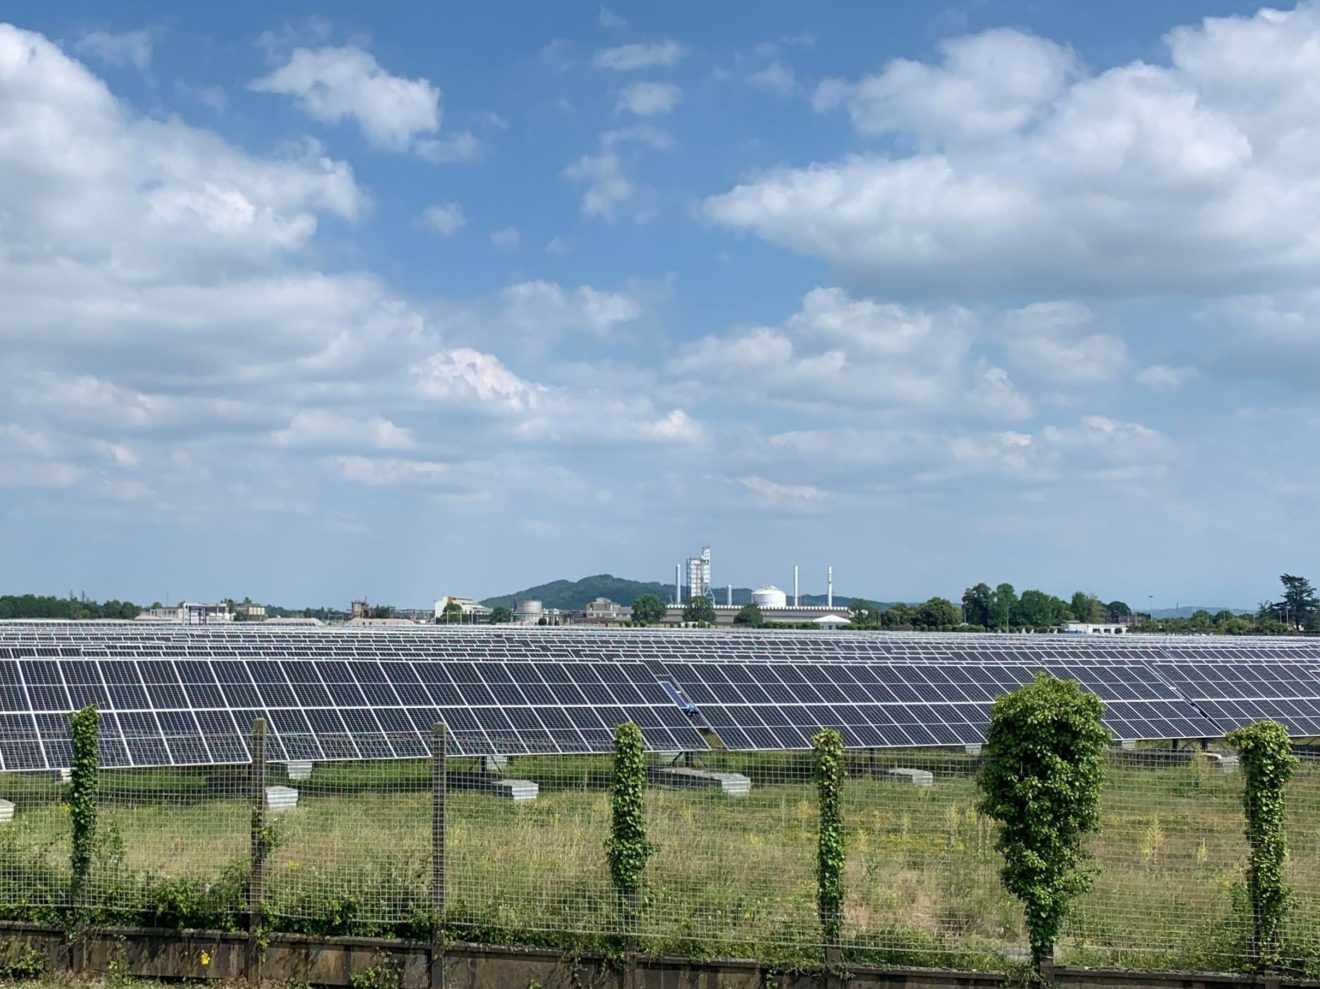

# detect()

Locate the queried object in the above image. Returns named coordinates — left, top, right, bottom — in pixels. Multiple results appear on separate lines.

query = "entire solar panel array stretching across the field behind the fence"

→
left=0, top=622, right=1320, bottom=770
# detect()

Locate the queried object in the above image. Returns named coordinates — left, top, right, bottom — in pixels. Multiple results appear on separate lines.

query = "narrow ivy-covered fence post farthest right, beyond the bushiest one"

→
left=1226, top=721, right=1298, bottom=968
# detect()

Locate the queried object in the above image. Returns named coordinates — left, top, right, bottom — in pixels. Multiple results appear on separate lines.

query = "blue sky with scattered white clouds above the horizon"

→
left=0, top=1, right=1320, bottom=607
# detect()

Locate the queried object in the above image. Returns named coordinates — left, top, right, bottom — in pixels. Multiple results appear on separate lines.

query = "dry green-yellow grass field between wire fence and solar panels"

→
left=0, top=753, right=1320, bottom=969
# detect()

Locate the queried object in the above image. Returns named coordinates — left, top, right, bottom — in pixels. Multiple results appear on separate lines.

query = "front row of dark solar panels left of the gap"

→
left=0, top=659, right=706, bottom=770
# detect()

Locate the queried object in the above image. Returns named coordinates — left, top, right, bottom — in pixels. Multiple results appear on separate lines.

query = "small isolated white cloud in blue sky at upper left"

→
left=249, top=45, right=441, bottom=151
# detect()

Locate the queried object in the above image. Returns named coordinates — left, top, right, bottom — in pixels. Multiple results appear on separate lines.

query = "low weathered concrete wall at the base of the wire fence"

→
left=0, top=923, right=1304, bottom=989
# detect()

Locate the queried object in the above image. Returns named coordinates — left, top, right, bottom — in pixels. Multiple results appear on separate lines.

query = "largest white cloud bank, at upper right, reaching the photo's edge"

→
left=706, top=3, right=1320, bottom=296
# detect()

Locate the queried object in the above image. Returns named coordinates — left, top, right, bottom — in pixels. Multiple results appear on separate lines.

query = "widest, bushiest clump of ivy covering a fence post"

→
left=978, top=673, right=1110, bottom=972
